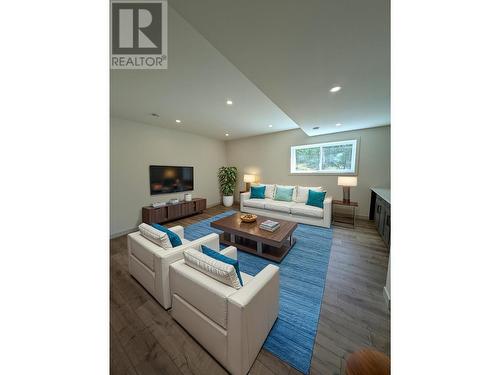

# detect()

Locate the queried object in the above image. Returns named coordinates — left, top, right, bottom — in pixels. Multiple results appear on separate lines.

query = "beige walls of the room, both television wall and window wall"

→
left=110, top=118, right=390, bottom=236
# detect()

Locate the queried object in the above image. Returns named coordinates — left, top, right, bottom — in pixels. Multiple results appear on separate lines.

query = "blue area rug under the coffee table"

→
left=184, top=211, right=333, bottom=374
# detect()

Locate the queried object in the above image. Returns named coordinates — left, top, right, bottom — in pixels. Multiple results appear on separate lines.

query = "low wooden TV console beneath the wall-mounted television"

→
left=142, top=198, right=207, bottom=224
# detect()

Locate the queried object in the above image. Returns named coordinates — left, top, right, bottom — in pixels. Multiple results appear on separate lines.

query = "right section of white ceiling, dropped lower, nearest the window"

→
left=169, top=0, right=390, bottom=135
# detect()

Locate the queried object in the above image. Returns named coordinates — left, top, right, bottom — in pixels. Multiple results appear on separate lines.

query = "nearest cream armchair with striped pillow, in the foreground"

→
left=170, top=246, right=279, bottom=375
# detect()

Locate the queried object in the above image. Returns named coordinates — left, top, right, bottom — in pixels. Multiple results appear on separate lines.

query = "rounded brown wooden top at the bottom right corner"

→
left=346, top=349, right=391, bottom=375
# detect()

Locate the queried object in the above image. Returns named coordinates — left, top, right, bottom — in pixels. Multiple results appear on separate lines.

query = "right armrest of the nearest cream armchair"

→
left=227, top=264, right=280, bottom=374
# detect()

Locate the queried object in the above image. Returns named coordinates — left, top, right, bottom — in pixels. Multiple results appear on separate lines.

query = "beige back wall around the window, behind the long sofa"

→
left=226, top=126, right=391, bottom=216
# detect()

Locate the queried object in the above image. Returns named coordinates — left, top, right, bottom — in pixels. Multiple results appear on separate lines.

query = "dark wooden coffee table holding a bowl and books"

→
left=210, top=214, right=297, bottom=262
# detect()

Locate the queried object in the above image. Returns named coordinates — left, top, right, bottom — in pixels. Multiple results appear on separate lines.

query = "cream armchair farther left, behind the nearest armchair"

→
left=127, top=226, right=219, bottom=309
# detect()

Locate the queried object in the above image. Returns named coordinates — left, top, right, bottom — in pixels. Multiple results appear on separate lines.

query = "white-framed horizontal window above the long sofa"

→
left=290, top=139, right=358, bottom=174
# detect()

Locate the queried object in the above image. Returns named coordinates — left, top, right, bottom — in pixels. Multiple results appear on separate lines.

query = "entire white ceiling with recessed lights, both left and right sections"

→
left=111, top=0, right=390, bottom=139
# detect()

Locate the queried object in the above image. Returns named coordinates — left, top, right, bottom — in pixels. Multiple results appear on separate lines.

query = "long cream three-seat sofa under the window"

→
left=240, top=184, right=332, bottom=228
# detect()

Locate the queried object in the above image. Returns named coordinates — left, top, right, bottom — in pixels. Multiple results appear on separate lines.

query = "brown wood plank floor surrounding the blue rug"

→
left=110, top=206, right=390, bottom=375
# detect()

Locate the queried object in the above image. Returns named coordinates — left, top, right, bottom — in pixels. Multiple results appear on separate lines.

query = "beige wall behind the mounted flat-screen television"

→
left=111, top=118, right=226, bottom=235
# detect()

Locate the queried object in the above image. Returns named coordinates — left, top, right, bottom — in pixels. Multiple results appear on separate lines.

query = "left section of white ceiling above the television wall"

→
left=111, top=7, right=298, bottom=140
